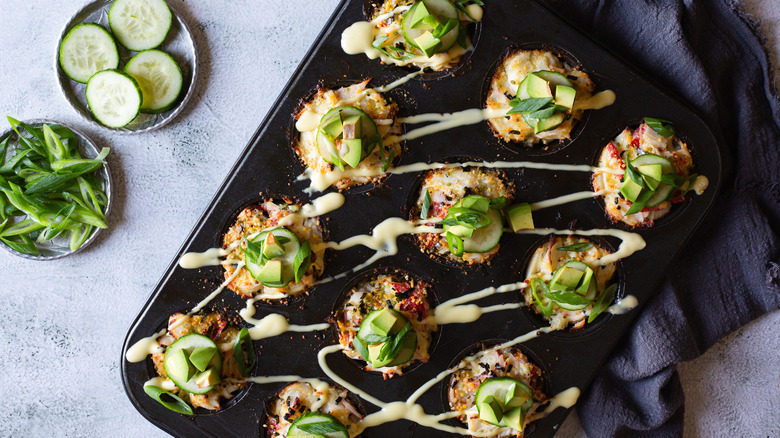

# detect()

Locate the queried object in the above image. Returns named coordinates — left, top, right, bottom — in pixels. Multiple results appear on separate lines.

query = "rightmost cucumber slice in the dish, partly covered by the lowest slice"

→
left=124, top=50, right=184, bottom=113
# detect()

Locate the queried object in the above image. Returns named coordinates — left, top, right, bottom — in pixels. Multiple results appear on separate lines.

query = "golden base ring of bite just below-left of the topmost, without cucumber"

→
left=293, top=80, right=402, bottom=190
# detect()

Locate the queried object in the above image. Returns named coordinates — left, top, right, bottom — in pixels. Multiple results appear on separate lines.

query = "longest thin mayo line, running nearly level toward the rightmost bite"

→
left=296, top=157, right=623, bottom=193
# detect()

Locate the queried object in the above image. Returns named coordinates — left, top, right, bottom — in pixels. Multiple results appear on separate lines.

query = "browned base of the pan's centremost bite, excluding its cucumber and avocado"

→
left=410, top=167, right=514, bottom=265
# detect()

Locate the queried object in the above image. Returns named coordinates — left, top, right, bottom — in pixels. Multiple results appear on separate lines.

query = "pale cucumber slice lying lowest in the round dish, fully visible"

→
left=86, top=70, right=143, bottom=128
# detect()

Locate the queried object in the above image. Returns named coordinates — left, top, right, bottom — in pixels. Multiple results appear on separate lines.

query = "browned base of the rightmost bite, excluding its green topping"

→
left=593, top=123, right=706, bottom=227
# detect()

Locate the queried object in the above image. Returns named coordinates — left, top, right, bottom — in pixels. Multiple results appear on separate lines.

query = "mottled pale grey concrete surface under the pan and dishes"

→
left=0, top=0, right=780, bottom=437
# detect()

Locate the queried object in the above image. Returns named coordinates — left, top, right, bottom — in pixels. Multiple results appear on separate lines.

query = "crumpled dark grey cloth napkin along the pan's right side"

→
left=547, top=0, right=780, bottom=437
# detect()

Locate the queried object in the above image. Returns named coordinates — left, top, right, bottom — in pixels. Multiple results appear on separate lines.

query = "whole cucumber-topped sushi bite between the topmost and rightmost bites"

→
left=485, top=49, right=594, bottom=147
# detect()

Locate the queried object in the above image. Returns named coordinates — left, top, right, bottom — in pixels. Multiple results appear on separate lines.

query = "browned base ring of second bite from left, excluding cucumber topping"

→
left=222, top=201, right=325, bottom=299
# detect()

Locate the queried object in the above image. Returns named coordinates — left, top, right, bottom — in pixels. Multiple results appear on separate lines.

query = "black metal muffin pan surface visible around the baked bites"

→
left=121, top=0, right=723, bottom=437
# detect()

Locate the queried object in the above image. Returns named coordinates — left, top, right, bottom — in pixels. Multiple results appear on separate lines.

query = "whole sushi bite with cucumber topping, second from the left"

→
left=222, top=199, right=325, bottom=299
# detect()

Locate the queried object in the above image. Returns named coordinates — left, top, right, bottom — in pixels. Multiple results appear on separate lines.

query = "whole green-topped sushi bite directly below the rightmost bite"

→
left=523, top=236, right=617, bottom=330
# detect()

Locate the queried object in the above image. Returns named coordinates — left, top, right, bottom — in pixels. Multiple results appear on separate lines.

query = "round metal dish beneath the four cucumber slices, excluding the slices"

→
left=54, top=0, right=198, bottom=134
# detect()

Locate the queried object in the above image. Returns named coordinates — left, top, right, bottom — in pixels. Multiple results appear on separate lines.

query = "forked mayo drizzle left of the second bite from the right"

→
left=424, top=281, right=526, bottom=325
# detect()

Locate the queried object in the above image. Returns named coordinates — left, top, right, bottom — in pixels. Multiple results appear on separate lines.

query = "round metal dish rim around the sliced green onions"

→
left=0, top=119, right=112, bottom=261
